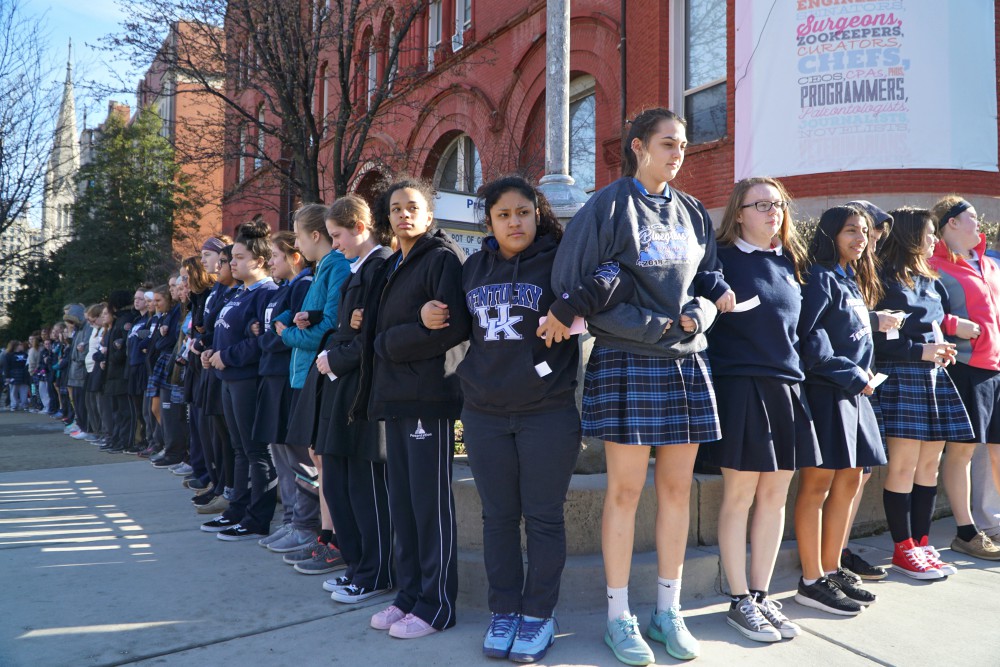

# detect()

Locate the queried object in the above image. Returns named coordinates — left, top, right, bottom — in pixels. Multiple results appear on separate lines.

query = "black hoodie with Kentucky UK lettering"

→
left=458, top=235, right=634, bottom=414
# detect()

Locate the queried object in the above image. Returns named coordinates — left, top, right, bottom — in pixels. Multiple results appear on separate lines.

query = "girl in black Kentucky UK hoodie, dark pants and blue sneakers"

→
left=422, top=176, right=631, bottom=662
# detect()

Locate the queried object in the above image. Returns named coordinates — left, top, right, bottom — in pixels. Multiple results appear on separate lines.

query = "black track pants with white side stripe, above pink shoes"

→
left=385, top=417, right=458, bottom=630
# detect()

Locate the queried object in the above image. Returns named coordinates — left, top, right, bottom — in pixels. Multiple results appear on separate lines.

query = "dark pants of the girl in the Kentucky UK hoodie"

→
left=462, top=406, right=580, bottom=618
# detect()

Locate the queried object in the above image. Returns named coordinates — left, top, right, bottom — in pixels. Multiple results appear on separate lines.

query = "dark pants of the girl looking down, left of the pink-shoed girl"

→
left=323, top=454, right=393, bottom=588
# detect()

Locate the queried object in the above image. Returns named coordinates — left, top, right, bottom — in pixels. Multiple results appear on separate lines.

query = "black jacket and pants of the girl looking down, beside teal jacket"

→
left=320, top=246, right=395, bottom=591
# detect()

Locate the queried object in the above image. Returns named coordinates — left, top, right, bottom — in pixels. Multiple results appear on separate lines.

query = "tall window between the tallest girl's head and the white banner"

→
left=672, top=0, right=727, bottom=144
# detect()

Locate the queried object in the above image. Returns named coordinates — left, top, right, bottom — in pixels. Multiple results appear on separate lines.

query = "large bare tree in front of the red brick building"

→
left=103, top=0, right=426, bottom=214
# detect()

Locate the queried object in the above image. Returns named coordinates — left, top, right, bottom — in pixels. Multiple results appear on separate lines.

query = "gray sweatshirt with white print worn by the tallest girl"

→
left=552, top=178, right=729, bottom=358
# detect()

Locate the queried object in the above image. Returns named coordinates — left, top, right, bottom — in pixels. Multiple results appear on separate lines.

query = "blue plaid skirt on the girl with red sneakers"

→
left=876, top=361, right=973, bottom=442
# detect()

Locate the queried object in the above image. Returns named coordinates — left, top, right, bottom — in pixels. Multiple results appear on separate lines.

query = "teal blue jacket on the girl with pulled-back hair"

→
left=275, top=251, right=351, bottom=389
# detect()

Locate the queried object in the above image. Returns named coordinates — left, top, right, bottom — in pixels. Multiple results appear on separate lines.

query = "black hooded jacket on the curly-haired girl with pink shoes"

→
left=352, top=229, right=469, bottom=420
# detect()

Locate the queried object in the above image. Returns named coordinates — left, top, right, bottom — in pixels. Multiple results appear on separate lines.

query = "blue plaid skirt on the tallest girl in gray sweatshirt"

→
left=581, top=345, right=720, bottom=447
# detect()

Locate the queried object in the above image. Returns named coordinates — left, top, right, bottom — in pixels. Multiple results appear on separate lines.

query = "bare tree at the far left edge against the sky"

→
left=0, top=0, right=56, bottom=275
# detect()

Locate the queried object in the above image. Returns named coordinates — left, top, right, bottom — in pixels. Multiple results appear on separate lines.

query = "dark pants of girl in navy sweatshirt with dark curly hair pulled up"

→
left=222, top=378, right=278, bottom=535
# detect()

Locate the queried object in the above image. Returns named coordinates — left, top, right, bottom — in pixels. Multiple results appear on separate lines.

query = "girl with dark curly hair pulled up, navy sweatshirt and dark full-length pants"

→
left=201, top=220, right=277, bottom=542
